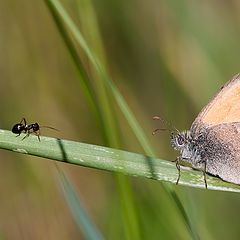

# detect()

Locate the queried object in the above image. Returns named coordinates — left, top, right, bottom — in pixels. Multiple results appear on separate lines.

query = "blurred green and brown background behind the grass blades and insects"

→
left=0, top=0, right=240, bottom=239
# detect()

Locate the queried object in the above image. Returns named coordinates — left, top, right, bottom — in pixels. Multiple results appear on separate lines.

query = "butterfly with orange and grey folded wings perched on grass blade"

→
left=171, top=75, right=240, bottom=186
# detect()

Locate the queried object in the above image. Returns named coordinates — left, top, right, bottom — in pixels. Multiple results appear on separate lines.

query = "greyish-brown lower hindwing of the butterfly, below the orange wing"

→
left=203, top=122, right=240, bottom=184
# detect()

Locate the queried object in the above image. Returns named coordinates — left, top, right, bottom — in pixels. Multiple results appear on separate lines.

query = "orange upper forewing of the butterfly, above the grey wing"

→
left=192, top=74, right=240, bottom=130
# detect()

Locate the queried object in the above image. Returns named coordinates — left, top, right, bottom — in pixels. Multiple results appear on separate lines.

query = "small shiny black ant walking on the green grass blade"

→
left=12, top=118, right=58, bottom=142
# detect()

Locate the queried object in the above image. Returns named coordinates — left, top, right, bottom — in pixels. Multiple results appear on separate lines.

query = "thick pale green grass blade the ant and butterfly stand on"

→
left=0, top=130, right=240, bottom=192
